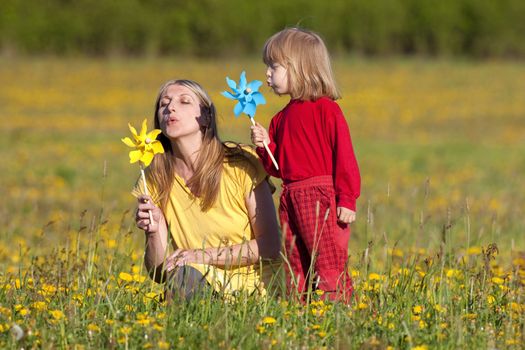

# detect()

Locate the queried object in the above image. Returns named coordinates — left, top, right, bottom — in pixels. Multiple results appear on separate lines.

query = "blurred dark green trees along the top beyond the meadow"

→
left=0, top=0, right=525, bottom=57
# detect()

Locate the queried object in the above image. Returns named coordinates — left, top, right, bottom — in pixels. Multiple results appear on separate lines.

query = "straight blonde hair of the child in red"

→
left=263, top=28, right=341, bottom=100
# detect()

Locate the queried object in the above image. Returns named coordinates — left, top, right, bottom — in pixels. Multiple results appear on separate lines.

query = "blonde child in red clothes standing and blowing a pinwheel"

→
left=251, top=28, right=361, bottom=302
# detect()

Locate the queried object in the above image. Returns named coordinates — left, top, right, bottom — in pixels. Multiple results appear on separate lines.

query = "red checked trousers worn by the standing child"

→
left=279, top=176, right=353, bottom=302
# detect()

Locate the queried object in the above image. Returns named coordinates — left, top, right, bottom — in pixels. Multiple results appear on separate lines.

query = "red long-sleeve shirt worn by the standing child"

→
left=257, top=97, right=361, bottom=211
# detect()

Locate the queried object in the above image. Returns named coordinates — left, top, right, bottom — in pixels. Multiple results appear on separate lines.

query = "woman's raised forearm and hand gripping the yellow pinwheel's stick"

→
left=135, top=195, right=168, bottom=282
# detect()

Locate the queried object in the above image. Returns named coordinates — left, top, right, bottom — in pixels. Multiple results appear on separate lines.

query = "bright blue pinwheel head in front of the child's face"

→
left=222, top=71, right=266, bottom=119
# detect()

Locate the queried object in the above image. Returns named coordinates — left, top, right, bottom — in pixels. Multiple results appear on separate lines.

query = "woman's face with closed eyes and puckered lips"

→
left=157, top=85, right=202, bottom=140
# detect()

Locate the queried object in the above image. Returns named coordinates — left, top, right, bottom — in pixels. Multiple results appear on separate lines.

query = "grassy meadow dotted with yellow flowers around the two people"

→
left=0, top=58, right=525, bottom=349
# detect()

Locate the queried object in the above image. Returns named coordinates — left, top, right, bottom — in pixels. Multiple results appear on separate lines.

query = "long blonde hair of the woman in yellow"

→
left=147, top=79, right=227, bottom=211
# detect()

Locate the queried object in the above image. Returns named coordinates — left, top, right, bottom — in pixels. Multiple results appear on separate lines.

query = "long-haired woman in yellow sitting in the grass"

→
left=134, top=80, right=280, bottom=299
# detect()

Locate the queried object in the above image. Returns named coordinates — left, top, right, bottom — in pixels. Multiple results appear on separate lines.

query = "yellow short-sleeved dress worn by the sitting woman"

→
left=133, top=148, right=275, bottom=295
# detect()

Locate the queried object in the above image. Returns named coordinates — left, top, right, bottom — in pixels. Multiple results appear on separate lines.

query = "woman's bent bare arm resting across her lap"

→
left=166, top=181, right=281, bottom=271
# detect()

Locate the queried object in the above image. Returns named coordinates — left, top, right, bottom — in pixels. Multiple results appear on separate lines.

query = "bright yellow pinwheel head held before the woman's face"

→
left=122, top=119, right=164, bottom=166
